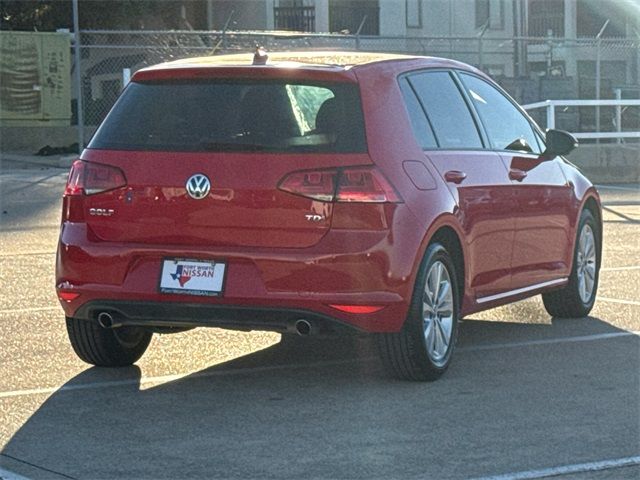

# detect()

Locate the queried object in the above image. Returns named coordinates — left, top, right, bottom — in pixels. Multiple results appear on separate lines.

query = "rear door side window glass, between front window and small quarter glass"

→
left=409, top=72, right=482, bottom=148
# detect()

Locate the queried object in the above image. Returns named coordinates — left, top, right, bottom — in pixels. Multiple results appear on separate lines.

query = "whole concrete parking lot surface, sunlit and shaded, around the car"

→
left=0, top=159, right=640, bottom=480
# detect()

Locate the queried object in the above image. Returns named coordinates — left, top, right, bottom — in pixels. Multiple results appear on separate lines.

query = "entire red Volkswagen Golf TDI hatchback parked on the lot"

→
left=56, top=52, right=602, bottom=380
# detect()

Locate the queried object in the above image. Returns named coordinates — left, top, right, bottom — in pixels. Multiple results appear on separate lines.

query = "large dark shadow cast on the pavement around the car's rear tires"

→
left=0, top=317, right=640, bottom=478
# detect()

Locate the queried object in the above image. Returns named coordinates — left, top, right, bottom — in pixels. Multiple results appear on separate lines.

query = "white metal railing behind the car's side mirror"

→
left=522, top=99, right=640, bottom=139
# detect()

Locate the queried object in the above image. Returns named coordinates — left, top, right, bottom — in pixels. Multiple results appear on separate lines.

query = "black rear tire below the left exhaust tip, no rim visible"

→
left=67, top=317, right=152, bottom=367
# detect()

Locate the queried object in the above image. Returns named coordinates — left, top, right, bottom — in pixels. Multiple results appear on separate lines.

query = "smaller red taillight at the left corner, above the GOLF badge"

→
left=64, top=160, right=127, bottom=196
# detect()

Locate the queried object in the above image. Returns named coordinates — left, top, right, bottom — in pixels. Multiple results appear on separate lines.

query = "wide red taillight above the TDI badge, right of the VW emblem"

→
left=278, top=166, right=402, bottom=203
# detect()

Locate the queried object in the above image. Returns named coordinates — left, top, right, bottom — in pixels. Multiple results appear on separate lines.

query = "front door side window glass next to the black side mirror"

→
left=460, top=73, right=540, bottom=153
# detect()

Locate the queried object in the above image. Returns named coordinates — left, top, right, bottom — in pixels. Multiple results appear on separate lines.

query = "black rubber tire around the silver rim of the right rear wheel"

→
left=378, top=243, right=460, bottom=381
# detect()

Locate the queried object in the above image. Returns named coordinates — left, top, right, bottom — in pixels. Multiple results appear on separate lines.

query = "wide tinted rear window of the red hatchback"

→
left=89, top=81, right=366, bottom=153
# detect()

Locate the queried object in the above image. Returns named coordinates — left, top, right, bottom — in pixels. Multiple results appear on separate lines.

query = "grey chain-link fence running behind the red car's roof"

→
left=74, top=31, right=640, bottom=142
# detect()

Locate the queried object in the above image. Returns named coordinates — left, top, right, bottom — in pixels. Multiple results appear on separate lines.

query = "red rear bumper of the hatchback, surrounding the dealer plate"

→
left=56, top=209, right=422, bottom=332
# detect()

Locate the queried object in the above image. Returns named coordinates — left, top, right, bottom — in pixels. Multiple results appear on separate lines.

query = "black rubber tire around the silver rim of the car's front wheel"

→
left=542, top=210, right=602, bottom=318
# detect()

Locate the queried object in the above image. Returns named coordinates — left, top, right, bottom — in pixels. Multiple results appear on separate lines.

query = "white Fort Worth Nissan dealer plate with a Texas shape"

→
left=160, top=258, right=226, bottom=296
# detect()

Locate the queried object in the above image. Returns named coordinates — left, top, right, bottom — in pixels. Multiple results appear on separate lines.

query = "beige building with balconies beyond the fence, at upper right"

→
left=252, top=0, right=640, bottom=98
